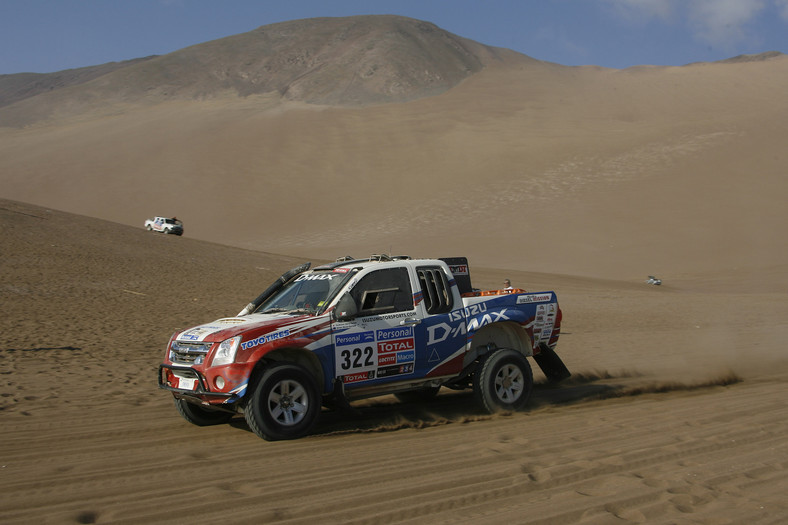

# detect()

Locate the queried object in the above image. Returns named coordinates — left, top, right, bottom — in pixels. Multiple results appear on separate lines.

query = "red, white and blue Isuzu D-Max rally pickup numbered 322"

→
left=158, top=256, right=570, bottom=440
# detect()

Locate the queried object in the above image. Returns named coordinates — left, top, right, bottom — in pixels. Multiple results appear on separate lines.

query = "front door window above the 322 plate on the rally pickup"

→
left=350, top=268, right=413, bottom=316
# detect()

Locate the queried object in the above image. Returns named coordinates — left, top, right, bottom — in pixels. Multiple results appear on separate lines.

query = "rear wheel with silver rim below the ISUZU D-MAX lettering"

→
left=473, top=349, right=534, bottom=414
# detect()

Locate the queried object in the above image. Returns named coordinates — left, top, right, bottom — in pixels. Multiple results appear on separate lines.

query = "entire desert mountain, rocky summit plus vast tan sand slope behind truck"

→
left=0, top=16, right=788, bottom=278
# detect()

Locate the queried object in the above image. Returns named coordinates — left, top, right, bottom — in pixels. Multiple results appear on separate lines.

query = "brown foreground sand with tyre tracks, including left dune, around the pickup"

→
left=0, top=200, right=788, bottom=524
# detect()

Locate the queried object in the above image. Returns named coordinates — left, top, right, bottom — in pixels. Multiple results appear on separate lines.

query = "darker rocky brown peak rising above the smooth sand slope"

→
left=0, top=16, right=528, bottom=124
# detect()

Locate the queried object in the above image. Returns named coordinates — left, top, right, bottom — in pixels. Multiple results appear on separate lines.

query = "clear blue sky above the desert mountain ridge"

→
left=0, top=0, right=788, bottom=74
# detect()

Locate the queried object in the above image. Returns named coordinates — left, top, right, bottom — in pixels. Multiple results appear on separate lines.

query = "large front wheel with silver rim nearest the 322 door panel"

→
left=244, top=364, right=320, bottom=441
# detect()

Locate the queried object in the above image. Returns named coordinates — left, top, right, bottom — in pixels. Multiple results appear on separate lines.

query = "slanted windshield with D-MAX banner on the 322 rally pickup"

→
left=255, top=268, right=354, bottom=314
